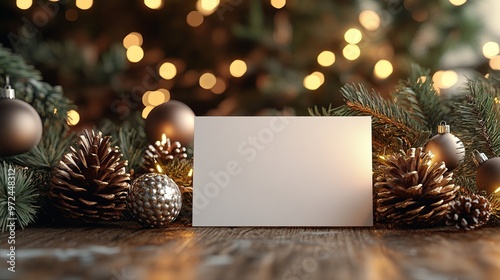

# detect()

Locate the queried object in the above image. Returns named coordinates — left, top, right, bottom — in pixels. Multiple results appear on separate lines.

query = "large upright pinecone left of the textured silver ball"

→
left=49, top=130, right=130, bottom=222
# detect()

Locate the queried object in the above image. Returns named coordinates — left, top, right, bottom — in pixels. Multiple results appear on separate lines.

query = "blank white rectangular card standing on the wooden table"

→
left=193, top=117, right=373, bottom=227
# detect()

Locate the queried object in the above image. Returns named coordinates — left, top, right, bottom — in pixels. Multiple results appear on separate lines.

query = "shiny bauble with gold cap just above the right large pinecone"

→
left=425, top=121, right=465, bottom=171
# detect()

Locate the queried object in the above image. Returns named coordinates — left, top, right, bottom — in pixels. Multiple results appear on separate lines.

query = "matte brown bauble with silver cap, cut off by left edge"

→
left=0, top=77, right=43, bottom=157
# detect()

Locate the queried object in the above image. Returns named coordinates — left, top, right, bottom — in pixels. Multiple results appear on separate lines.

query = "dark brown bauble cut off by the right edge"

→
left=472, top=150, right=500, bottom=194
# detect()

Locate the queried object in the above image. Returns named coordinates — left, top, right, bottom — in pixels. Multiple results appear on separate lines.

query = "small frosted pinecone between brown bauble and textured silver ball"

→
left=144, top=137, right=187, bottom=173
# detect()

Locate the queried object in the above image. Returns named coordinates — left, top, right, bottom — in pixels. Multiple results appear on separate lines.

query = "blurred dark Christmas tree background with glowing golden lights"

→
left=0, top=0, right=498, bottom=126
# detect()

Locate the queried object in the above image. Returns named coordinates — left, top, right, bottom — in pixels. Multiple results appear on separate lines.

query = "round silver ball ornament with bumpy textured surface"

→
left=127, top=173, right=182, bottom=227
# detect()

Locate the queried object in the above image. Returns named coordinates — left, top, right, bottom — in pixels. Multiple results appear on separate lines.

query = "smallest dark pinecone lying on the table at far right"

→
left=446, top=194, right=491, bottom=230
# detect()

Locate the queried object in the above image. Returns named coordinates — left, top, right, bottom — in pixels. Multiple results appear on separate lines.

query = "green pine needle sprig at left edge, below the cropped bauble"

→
left=0, top=162, right=39, bottom=232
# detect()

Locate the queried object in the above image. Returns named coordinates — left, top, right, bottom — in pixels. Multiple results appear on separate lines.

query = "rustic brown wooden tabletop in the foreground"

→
left=0, top=222, right=500, bottom=280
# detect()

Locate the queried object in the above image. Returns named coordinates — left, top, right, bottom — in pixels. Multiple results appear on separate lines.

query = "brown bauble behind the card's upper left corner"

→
left=145, top=100, right=195, bottom=146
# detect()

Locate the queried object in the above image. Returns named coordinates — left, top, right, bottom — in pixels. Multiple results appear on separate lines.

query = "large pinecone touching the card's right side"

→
left=375, top=147, right=460, bottom=226
